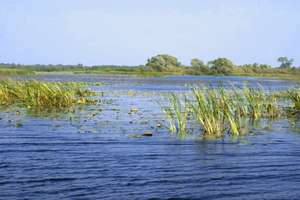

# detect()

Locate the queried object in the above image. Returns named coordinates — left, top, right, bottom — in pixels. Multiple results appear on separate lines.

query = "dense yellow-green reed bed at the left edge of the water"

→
left=0, top=80, right=93, bottom=109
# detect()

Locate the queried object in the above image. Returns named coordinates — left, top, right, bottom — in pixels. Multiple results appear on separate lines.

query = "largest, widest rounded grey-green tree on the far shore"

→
left=146, top=54, right=181, bottom=71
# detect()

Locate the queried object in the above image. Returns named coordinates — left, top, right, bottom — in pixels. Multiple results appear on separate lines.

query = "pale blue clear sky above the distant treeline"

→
left=0, top=0, right=300, bottom=66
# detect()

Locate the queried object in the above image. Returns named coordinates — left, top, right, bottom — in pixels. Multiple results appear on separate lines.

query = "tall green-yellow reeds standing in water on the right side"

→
left=161, top=87, right=300, bottom=137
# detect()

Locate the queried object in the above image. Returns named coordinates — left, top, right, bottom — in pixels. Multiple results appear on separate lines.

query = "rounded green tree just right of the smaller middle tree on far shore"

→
left=208, top=58, right=234, bottom=74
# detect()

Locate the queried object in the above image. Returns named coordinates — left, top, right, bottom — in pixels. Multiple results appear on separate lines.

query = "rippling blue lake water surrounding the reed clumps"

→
left=0, top=75, right=300, bottom=199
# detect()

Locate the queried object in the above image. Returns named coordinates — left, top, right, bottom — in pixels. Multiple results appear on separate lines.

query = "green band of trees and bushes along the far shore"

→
left=0, top=54, right=300, bottom=79
